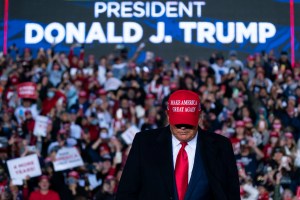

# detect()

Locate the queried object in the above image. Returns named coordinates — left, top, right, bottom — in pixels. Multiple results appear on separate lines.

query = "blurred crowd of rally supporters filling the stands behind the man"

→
left=0, top=45, right=300, bottom=200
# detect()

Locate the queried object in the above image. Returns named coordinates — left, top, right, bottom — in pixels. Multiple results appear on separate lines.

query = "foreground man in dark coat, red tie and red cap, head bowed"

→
left=117, top=90, right=240, bottom=200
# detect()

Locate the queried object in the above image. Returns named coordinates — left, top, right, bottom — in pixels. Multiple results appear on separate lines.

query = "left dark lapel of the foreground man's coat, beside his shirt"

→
left=155, top=126, right=174, bottom=195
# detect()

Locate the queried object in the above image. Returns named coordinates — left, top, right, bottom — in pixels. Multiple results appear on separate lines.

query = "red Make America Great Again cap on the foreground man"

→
left=167, top=90, right=201, bottom=126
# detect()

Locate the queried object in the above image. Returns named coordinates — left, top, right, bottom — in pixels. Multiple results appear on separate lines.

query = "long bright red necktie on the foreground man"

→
left=175, top=142, right=189, bottom=200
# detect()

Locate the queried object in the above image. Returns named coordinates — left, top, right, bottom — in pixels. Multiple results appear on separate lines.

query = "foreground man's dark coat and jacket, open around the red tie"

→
left=117, top=126, right=240, bottom=200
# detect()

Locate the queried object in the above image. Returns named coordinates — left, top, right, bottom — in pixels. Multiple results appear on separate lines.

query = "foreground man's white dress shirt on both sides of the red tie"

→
left=172, top=133, right=198, bottom=182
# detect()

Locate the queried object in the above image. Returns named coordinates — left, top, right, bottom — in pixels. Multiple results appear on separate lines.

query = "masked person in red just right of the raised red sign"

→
left=41, top=87, right=66, bottom=115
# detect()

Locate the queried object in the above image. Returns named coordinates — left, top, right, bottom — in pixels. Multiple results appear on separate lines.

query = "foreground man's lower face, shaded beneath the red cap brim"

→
left=170, top=124, right=198, bottom=142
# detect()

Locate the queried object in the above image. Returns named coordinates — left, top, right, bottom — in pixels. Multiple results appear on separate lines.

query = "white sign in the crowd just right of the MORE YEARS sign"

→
left=53, top=147, right=83, bottom=171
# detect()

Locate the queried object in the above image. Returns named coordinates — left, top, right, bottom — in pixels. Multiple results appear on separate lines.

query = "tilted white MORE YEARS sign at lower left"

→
left=7, top=154, right=42, bottom=180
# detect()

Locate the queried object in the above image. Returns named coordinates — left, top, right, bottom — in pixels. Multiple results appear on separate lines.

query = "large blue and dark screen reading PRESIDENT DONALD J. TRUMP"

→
left=0, top=0, right=300, bottom=60
